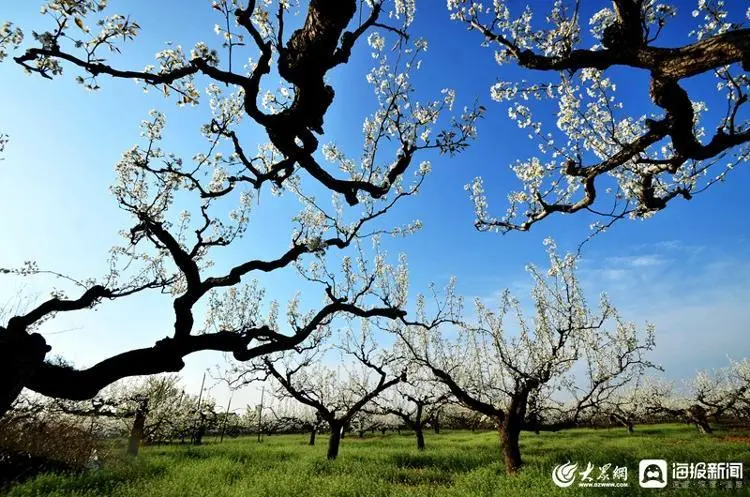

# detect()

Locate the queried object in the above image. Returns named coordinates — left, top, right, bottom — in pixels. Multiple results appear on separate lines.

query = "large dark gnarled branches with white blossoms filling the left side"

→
left=0, top=0, right=482, bottom=412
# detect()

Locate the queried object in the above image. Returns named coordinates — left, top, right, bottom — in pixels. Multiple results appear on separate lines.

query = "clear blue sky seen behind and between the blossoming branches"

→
left=0, top=0, right=750, bottom=406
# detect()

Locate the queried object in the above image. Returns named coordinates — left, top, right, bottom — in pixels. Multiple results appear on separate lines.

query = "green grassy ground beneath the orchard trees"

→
left=9, top=425, right=750, bottom=497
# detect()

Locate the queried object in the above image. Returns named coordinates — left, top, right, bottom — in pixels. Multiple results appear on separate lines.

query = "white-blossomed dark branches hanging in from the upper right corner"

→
left=448, top=0, right=750, bottom=233
